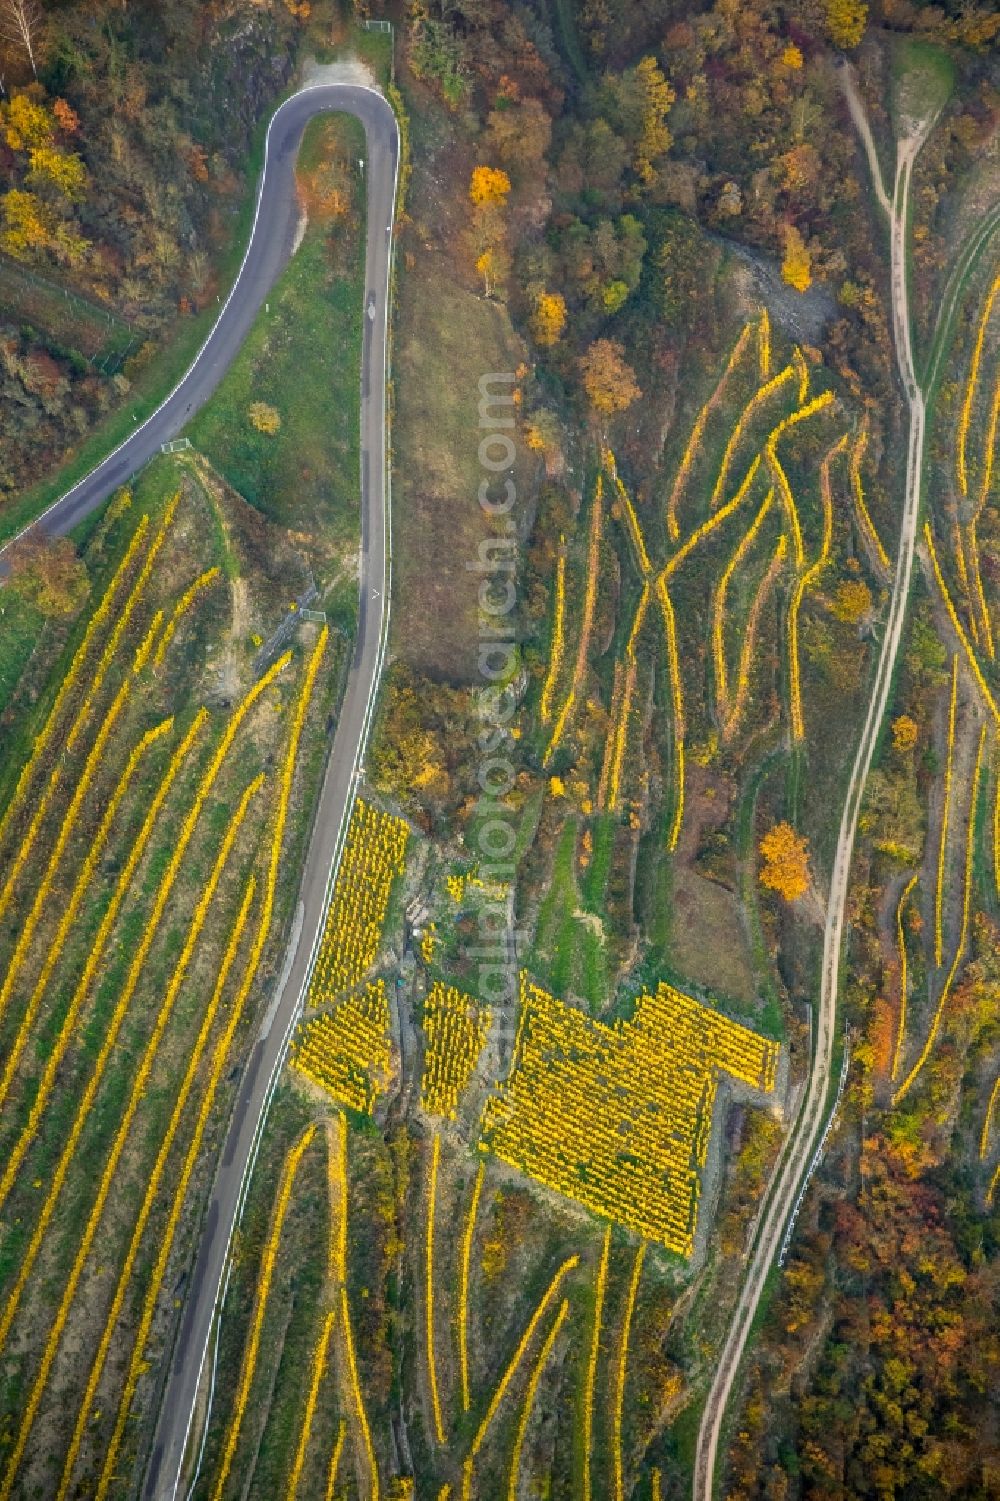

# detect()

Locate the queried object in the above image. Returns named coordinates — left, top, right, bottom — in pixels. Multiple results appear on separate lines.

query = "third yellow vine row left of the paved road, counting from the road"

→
left=0, top=775, right=264, bottom=1501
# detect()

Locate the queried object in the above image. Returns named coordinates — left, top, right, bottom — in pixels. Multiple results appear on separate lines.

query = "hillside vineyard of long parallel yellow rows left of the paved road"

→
left=0, top=471, right=329, bottom=1501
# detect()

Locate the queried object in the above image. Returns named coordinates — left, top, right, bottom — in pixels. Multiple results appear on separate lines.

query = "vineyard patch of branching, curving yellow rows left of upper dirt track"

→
left=539, top=312, right=858, bottom=876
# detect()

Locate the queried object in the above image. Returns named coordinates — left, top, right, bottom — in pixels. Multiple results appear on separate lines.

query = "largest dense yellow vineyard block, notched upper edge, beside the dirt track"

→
left=482, top=977, right=778, bottom=1256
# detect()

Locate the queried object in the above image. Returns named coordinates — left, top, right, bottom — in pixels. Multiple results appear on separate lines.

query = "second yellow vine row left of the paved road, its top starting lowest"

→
left=57, top=877, right=255, bottom=1501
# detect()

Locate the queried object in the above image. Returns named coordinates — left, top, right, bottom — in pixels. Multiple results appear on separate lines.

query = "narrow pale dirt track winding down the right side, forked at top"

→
left=694, top=73, right=934, bottom=1501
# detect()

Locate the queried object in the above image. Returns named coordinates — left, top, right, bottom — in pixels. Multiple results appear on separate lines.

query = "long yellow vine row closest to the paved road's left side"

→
left=95, top=626, right=329, bottom=1501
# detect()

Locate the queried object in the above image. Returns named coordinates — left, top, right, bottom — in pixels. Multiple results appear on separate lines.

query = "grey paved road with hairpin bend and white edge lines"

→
left=0, top=83, right=399, bottom=1501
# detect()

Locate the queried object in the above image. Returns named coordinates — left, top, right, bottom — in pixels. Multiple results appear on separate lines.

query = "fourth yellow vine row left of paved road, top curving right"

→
left=0, top=653, right=291, bottom=1350
